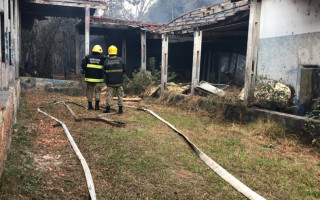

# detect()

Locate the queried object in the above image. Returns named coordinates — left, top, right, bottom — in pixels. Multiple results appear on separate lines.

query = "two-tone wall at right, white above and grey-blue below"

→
left=257, top=0, right=320, bottom=88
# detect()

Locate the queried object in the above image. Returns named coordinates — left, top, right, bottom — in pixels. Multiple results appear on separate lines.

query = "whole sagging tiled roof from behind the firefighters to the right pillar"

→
left=80, top=0, right=250, bottom=34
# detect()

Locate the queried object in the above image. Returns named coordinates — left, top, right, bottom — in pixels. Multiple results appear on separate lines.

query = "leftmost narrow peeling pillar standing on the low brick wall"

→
left=2, top=0, right=10, bottom=88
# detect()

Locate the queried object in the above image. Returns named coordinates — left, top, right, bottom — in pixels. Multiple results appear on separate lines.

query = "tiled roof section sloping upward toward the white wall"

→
left=156, top=0, right=250, bottom=33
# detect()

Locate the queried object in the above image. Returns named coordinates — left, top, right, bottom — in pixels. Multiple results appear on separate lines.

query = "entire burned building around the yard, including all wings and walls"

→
left=0, top=0, right=320, bottom=178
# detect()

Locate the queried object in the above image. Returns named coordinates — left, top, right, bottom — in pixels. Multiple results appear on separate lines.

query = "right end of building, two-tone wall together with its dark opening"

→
left=257, top=0, right=320, bottom=115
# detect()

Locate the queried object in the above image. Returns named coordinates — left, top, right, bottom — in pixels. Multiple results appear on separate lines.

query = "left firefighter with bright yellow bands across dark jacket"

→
left=82, top=45, right=107, bottom=110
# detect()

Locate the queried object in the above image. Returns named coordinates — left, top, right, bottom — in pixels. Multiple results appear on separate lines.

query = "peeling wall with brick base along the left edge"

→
left=0, top=0, right=20, bottom=176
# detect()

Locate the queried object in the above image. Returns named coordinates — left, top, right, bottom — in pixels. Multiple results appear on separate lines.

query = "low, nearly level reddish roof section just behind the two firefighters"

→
left=90, top=16, right=164, bottom=32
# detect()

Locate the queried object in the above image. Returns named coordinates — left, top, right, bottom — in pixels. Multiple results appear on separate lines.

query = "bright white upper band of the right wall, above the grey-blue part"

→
left=260, top=0, right=320, bottom=38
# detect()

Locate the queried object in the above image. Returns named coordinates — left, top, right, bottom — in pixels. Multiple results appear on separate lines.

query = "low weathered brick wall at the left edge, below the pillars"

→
left=0, top=80, right=20, bottom=176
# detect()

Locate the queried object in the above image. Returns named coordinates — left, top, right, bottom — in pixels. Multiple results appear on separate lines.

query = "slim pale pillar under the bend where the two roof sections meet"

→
left=161, top=34, right=169, bottom=91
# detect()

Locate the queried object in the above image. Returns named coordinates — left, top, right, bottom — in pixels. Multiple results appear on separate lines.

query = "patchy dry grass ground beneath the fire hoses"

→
left=0, top=92, right=320, bottom=199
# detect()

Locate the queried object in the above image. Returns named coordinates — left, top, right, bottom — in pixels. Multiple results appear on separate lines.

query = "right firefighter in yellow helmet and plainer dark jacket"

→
left=104, top=45, right=126, bottom=114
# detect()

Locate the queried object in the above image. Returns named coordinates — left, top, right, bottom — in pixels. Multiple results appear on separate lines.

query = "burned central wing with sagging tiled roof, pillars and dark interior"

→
left=78, top=0, right=250, bottom=94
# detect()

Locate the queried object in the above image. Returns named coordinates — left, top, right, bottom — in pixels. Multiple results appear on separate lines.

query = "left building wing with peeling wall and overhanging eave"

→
left=0, top=0, right=107, bottom=177
